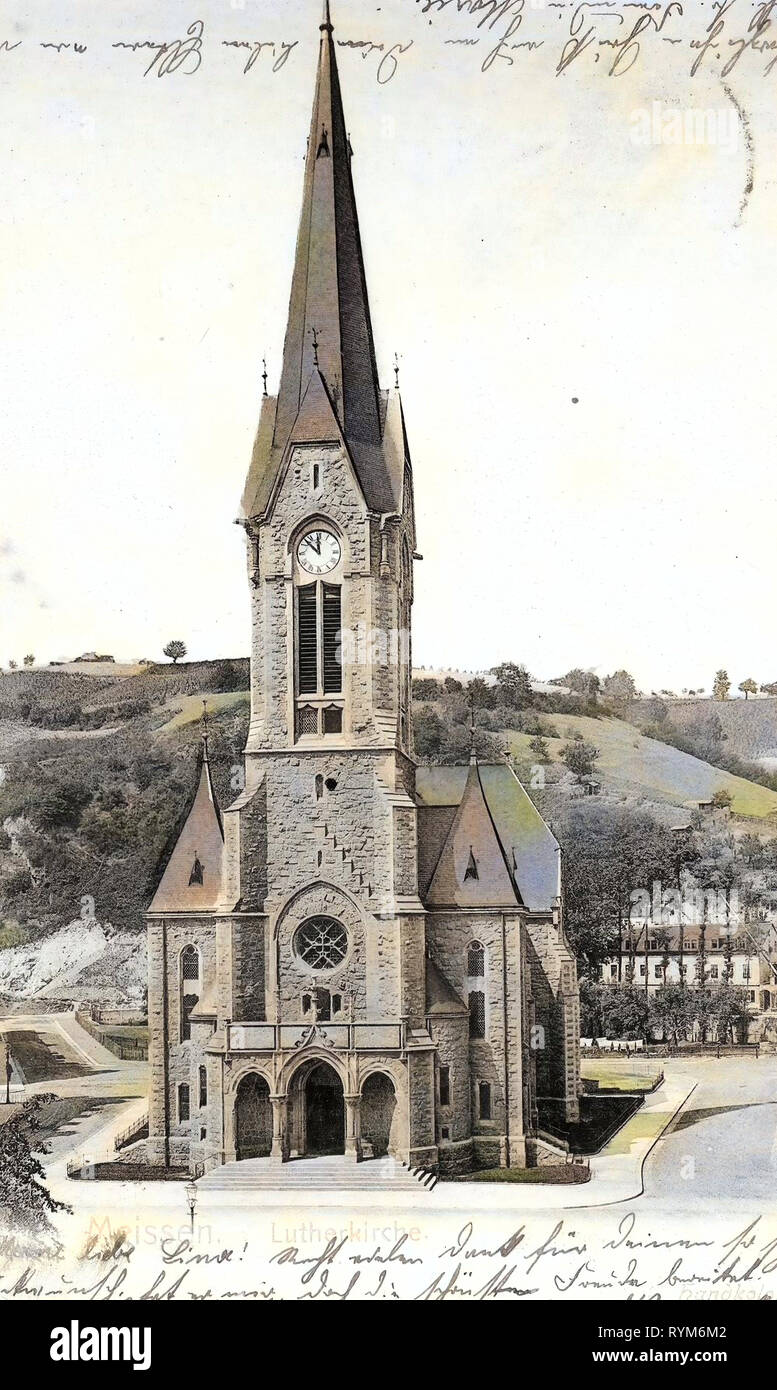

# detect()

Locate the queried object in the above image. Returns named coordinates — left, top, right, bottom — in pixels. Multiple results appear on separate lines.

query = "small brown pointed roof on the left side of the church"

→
left=149, top=724, right=224, bottom=912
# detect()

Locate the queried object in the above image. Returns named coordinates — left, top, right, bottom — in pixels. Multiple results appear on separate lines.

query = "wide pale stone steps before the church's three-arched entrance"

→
left=197, top=1155, right=428, bottom=1193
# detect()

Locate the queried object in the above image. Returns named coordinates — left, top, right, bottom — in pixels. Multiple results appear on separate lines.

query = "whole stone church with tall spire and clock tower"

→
left=146, top=4, right=580, bottom=1176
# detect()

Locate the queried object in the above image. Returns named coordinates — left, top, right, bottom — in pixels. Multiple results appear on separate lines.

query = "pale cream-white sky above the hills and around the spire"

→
left=0, top=0, right=777, bottom=691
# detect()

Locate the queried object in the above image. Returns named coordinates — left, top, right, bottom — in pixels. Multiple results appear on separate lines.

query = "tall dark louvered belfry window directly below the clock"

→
left=295, top=525, right=343, bottom=738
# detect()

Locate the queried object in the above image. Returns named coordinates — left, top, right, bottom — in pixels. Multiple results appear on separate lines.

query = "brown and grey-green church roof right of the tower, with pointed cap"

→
left=416, top=765, right=560, bottom=912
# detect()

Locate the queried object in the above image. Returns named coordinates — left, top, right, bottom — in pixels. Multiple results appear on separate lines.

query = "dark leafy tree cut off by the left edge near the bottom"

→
left=0, top=1094, right=71, bottom=1234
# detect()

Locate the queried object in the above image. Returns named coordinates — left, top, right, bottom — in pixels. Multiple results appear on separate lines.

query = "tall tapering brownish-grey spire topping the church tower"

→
left=274, top=0, right=381, bottom=467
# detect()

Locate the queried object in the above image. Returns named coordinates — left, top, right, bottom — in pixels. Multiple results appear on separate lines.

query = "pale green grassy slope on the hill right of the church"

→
left=509, top=702, right=777, bottom=817
